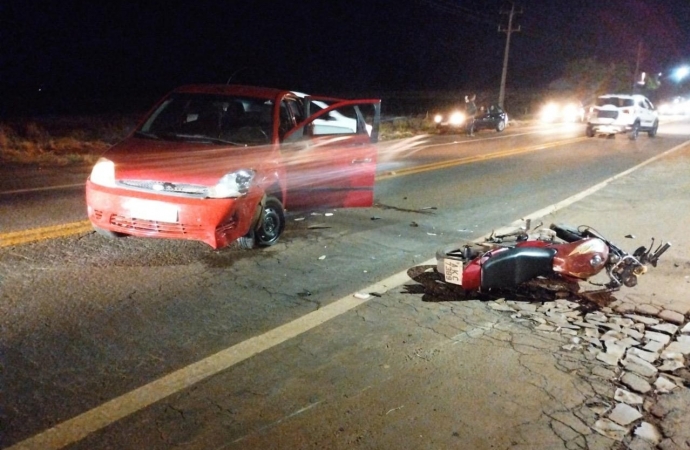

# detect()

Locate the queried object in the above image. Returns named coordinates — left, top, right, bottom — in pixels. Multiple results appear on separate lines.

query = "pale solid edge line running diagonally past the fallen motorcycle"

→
left=5, top=141, right=690, bottom=450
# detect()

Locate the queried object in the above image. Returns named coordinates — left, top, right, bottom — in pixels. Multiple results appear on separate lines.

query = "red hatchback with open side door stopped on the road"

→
left=86, top=85, right=381, bottom=248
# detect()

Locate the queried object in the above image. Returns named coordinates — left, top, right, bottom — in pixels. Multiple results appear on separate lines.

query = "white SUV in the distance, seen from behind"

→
left=586, top=94, right=659, bottom=140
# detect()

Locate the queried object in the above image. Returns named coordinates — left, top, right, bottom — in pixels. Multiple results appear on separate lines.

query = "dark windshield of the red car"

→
left=137, top=93, right=273, bottom=146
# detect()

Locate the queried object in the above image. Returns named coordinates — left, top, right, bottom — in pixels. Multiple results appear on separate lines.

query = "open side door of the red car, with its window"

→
left=281, top=97, right=381, bottom=209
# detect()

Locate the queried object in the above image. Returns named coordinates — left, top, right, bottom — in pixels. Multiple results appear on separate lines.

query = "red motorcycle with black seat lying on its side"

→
left=436, top=221, right=671, bottom=307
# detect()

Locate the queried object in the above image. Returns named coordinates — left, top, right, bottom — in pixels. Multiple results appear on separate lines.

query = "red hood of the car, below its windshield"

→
left=103, top=137, right=273, bottom=185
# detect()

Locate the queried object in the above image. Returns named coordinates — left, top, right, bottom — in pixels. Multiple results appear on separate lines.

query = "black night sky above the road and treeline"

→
left=0, top=0, right=690, bottom=116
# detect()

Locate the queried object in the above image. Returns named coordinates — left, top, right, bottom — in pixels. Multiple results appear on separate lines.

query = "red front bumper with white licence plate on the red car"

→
left=86, top=180, right=262, bottom=249
